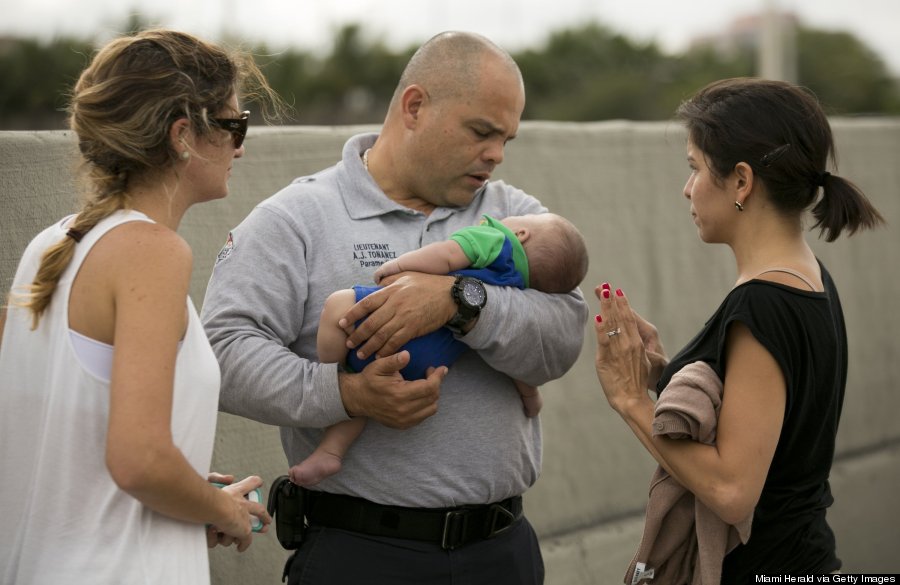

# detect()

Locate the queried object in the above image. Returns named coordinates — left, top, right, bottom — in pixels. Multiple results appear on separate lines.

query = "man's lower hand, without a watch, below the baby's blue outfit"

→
left=339, top=351, right=448, bottom=429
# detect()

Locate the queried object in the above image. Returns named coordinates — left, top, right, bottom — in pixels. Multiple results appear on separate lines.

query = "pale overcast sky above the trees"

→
left=0, top=0, right=900, bottom=75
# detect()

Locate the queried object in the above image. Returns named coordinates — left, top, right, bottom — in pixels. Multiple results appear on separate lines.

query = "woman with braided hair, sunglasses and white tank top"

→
left=0, top=30, right=271, bottom=585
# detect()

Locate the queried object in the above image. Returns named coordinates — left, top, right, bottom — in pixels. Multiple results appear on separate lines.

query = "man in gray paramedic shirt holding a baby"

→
left=203, top=32, right=587, bottom=585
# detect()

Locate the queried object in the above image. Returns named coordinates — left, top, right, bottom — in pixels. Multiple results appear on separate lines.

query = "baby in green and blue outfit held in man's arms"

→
left=290, top=213, right=588, bottom=486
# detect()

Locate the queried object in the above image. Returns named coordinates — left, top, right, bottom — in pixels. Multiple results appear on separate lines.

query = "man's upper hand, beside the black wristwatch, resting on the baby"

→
left=338, top=272, right=456, bottom=359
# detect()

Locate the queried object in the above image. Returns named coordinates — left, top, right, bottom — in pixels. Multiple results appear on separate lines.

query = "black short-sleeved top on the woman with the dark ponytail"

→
left=657, top=262, right=847, bottom=585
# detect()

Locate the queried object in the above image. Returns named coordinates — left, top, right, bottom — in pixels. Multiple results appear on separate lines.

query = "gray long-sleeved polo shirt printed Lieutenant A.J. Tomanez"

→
left=202, top=134, right=587, bottom=508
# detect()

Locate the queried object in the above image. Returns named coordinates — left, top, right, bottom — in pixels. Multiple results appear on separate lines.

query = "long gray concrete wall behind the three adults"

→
left=0, top=119, right=900, bottom=585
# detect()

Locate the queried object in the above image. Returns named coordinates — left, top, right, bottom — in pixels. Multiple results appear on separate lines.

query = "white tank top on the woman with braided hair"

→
left=0, top=211, right=219, bottom=585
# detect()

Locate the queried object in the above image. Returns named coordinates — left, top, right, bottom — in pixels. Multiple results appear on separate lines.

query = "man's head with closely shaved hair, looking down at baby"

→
left=366, top=32, right=525, bottom=214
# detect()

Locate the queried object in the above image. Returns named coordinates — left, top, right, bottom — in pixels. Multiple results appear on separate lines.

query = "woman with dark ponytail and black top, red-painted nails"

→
left=595, top=79, right=882, bottom=585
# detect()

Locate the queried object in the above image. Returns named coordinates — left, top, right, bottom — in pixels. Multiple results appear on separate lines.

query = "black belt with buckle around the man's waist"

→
left=303, top=489, right=522, bottom=550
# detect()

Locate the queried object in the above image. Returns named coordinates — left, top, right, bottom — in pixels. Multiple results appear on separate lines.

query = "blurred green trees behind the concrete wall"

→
left=0, top=18, right=900, bottom=129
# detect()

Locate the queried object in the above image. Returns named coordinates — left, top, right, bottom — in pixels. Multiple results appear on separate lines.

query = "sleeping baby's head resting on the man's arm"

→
left=501, top=213, right=588, bottom=293
